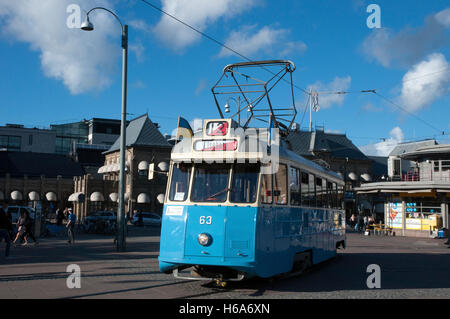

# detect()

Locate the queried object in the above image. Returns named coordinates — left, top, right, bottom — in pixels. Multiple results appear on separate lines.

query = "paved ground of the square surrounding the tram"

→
left=0, top=227, right=450, bottom=299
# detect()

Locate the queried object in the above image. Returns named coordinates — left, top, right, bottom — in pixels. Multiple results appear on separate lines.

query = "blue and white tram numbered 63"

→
left=159, top=119, right=346, bottom=281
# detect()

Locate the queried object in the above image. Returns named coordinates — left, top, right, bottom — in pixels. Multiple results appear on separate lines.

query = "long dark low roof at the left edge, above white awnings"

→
left=0, top=151, right=84, bottom=178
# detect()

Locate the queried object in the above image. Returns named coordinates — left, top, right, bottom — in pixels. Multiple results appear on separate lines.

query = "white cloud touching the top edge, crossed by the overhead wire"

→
left=153, top=0, right=257, bottom=51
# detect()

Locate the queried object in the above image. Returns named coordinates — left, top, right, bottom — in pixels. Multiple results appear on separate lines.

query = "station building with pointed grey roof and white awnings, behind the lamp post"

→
left=73, top=114, right=172, bottom=219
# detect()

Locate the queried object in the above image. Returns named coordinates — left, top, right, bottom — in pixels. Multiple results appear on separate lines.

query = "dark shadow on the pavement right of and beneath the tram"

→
left=220, top=253, right=450, bottom=296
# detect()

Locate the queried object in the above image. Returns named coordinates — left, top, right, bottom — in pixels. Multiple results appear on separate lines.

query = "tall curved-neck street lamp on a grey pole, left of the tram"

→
left=81, top=7, right=128, bottom=251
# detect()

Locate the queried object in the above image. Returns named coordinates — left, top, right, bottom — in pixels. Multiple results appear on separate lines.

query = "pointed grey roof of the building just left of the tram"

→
left=105, top=114, right=172, bottom=153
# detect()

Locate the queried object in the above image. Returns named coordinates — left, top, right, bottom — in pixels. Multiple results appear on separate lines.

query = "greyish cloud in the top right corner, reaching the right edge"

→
left=361, top=8, right=450, bottom=67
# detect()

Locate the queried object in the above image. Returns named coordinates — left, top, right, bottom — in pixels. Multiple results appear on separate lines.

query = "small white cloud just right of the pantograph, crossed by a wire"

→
left=308, top=76, right=352, bottom=108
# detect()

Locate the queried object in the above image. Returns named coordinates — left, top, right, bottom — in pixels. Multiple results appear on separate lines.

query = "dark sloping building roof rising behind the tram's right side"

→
left=287, top=131, right=369, bottom=160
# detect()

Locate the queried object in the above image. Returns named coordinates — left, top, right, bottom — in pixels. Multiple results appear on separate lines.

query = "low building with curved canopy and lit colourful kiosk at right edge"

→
left=356, top=143, right=450, bottom=237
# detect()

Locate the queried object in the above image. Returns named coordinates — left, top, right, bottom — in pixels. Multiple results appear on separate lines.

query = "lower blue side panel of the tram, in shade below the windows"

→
left=256, top=206, right=345, bottom=277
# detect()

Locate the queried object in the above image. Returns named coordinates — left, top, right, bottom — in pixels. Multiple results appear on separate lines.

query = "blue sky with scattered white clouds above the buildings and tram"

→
left=0, top=0, right=450, bottom=155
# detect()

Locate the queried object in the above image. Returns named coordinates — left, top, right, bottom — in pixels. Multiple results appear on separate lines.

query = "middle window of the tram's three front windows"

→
left=191, top=164, right=230, bottom=202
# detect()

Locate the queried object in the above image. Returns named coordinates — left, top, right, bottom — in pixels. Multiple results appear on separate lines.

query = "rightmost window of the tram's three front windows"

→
left=230, top=164, right=259, bottom=203
